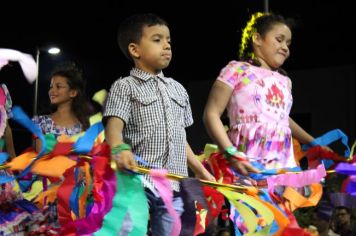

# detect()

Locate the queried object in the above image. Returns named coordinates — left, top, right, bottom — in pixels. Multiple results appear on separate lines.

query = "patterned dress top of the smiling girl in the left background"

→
left=32, top=115, right=82, bottom=138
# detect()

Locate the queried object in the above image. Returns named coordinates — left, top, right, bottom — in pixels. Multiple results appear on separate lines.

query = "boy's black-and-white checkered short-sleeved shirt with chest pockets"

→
left=104, top=68, right=193, bottom=191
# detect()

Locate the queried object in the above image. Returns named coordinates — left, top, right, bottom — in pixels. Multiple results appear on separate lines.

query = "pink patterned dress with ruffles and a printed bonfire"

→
left=217, top=61, right=296, bottom=169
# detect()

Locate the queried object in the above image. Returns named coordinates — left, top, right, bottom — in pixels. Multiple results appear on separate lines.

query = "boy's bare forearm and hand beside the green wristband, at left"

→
left=105, top=116, right=137, bottom=170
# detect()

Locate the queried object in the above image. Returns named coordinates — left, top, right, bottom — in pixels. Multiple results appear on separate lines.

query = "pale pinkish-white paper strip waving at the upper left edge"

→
left=0, top=48, right=38, bottom=83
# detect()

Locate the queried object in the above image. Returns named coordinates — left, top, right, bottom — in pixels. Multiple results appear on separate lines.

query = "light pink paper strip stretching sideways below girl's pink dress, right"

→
left=267, top=164, right=326, bottom=192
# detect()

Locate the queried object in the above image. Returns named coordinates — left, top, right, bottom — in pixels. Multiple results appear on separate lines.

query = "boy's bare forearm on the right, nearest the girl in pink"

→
left=185, top=142, right=216, bottom=181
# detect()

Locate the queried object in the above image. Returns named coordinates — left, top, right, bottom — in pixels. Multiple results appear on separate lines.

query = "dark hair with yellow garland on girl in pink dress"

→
left=239, top=12, right=294, bottom=74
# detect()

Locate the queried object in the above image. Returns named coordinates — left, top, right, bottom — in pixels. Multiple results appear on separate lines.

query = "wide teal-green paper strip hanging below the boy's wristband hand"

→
left=94, top=171, right=148, bottom=236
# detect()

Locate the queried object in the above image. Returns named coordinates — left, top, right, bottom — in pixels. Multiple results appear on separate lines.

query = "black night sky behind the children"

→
left=0, top=0, right=356, bottom=153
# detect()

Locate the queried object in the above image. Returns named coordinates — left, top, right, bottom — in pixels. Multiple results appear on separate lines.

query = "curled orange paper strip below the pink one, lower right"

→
left=283, top=183, right=323, bottom=211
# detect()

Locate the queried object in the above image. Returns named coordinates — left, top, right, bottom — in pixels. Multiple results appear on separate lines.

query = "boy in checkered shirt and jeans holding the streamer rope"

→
left=104, top=14, right=214, bottom=235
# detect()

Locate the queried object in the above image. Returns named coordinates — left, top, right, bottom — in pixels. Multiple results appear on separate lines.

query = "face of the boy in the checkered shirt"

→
left=129, top=25, right=172, bottom=74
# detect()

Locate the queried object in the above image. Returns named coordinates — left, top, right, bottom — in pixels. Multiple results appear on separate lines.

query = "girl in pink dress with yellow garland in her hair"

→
left=204, top=13, right=314, bottom=175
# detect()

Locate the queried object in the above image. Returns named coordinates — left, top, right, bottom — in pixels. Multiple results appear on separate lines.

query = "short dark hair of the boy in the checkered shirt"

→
left=117, top=13, right=168, bottom=60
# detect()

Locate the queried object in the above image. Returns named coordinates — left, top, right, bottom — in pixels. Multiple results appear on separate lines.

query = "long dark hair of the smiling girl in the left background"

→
left=51, top=62, right=90, bottom=130
